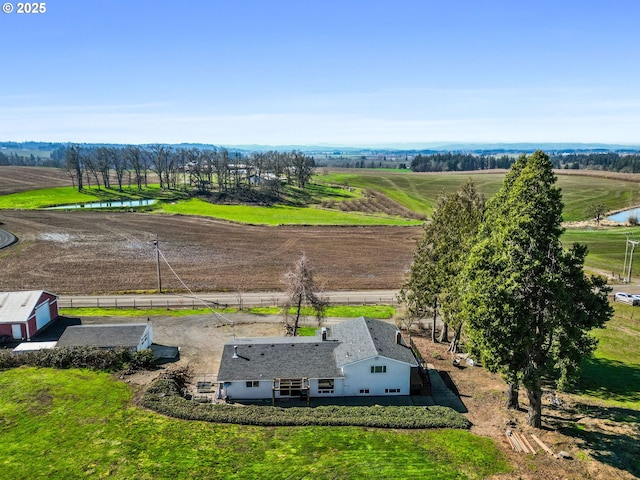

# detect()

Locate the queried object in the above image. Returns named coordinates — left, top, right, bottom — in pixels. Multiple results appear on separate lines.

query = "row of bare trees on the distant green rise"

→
left=65, top=145, right=315, bottom=196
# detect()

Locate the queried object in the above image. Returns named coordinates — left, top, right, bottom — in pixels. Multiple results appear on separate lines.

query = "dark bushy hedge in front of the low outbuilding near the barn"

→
left=0, top=347, right=150, bottom=371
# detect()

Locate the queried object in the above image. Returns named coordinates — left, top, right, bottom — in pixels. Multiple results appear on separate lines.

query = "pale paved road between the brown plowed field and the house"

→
left=58, top=290, right=397, bottom=308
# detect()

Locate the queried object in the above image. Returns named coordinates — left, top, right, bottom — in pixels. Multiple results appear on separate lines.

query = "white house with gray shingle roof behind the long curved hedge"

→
left=218, top=317, right=428, bottom=401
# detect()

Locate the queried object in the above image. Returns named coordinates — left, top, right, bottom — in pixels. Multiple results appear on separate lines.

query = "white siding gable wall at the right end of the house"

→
left=342, top=357, right=411, bottom=396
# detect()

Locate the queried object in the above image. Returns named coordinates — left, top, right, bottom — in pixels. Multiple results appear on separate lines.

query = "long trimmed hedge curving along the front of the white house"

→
left=141, top=379, right=471, bottom=429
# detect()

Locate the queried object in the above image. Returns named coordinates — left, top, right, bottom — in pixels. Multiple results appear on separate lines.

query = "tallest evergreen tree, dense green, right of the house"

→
left=462, top=151, right=612, bottom=427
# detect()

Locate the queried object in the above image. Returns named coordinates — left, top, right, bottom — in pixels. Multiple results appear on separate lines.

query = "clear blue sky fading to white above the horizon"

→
left=0, top=0, right=640, bottom=146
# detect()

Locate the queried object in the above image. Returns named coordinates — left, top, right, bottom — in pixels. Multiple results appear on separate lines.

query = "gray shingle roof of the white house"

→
left=218, top=317, right=416, bottom=381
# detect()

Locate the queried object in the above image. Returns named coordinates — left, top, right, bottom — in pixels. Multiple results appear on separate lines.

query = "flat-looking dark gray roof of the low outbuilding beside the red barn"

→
left=57, top=323, right=147, bottom=348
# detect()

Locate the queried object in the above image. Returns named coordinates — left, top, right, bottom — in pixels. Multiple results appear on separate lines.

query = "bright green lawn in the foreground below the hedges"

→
left=0, top=368, right=510, bottom=479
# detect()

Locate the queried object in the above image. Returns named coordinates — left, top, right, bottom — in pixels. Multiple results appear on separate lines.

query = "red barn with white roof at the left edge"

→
left=0, top=290, right=58, bottom=340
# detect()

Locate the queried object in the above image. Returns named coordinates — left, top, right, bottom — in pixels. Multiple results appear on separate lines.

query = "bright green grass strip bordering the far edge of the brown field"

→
left=162, top=198, right=422, bottom=225
